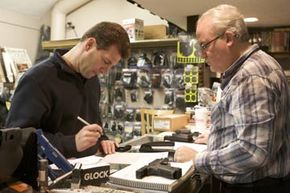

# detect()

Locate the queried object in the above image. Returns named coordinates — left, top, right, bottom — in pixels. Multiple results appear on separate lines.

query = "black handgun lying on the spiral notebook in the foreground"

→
left=136, top=158, right=182, bottom=179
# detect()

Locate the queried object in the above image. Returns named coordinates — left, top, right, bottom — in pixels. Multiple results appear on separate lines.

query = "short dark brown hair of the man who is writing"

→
left=81, top=22, right=130, bottom=58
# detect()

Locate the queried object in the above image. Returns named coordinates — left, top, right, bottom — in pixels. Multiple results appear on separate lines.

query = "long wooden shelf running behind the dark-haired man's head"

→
left=42, top=38, right=178, bottom=50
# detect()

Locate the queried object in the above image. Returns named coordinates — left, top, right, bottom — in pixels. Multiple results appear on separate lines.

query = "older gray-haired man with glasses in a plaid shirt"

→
left=175, top=5, right=290, bottom=193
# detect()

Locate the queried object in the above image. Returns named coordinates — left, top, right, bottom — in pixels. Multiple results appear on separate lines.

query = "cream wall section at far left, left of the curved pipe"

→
left=0, top=6, right=50, bottom=62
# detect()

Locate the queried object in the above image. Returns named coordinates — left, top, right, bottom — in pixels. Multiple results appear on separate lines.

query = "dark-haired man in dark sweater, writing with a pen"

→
left=6, top=22, right=130, bottom=158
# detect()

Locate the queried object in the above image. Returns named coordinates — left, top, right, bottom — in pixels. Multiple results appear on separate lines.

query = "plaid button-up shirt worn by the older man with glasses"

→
left=195, top=45, right=290, bottom=183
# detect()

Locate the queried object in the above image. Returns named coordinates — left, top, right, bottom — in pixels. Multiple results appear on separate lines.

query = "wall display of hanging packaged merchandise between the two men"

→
left=94, top=36, right=208, bottom=141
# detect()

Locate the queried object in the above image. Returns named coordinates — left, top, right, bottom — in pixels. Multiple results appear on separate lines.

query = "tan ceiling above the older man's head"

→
left=134, top=0, right=290, bottom=29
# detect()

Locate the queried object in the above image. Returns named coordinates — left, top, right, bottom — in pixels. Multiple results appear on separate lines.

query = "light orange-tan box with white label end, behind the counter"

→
left=153, top=114, right=188, bottom=131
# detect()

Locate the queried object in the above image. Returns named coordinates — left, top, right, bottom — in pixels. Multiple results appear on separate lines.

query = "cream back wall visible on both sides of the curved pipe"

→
left=0, top=0, right=168, bottom=63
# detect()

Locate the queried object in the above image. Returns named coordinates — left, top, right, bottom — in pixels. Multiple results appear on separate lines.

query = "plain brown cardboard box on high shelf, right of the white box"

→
left=144, top=25, right=168, bottom=39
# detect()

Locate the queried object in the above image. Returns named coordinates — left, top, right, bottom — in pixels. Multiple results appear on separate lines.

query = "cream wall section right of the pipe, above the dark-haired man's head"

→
left=66, top=0, right=168, bottom=39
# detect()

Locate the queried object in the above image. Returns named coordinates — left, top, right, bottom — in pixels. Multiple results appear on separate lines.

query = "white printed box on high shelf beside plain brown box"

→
left=122, top=18, right=144, bottom=41
